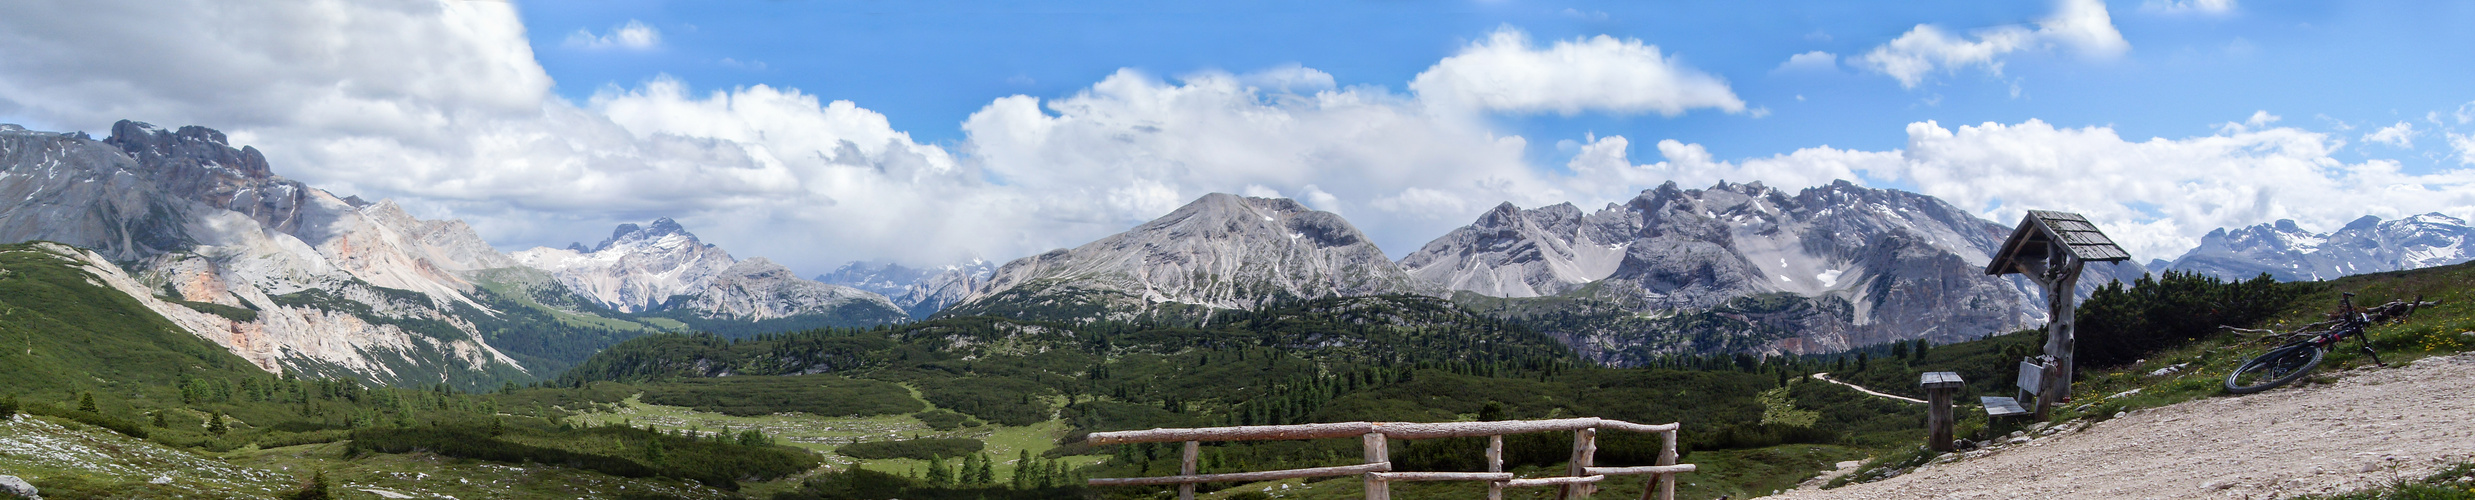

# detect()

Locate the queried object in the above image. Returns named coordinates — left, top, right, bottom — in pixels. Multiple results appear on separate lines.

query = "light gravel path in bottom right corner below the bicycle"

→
left=1772, top=354, right=2475, bottom=500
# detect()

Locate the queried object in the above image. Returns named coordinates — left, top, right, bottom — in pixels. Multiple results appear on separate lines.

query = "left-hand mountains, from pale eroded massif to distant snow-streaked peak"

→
left=0, top=121, right=906, bottom=389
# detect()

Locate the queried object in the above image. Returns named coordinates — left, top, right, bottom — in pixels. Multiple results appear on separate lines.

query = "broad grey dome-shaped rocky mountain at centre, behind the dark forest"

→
left=960, top=193, right=1440, bottom=319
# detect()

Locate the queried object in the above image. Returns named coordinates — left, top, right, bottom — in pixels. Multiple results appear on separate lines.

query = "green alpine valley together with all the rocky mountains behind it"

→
left=0, top=121, right=2468, bottom=500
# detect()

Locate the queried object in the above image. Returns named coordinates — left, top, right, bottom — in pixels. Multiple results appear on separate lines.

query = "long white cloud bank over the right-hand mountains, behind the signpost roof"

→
left=1574, top=119, right=2475, bottom=260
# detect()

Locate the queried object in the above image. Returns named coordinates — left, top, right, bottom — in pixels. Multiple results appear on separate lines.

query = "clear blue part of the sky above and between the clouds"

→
left=522, top=0, right=2475, bottom=168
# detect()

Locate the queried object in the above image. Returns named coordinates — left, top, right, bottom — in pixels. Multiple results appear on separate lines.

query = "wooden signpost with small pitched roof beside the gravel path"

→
left=1985, top=210, right=2131, bottom=421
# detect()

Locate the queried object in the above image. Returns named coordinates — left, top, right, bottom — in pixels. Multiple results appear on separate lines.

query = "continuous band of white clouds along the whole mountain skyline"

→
left=0, top=2, right=2475, bottom=272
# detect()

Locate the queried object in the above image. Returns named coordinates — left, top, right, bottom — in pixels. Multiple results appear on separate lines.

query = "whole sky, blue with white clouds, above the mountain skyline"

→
left=0, top=0, right=2475, bottom=275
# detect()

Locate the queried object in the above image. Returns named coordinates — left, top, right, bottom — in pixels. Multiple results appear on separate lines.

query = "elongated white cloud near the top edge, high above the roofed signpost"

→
left=1849, top=0, right=2131, bottom=89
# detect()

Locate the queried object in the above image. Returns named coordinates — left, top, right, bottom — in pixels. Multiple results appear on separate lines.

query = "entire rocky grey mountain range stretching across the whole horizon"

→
left=0, top=121, right=2475, bottom=386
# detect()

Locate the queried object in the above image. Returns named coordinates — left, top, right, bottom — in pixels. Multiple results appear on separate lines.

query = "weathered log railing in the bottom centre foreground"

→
left=1089, top=418, right=1693, bottom=500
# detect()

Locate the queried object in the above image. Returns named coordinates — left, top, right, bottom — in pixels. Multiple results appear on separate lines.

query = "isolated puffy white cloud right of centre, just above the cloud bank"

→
left=1408, top=27, right=1745, bottom=116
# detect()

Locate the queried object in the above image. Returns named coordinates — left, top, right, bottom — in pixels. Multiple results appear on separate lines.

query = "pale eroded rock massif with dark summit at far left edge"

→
left=0, top=121, right=522, bottom=384
